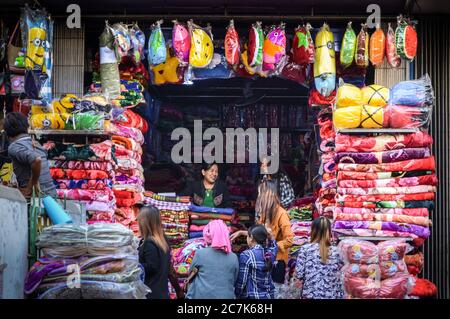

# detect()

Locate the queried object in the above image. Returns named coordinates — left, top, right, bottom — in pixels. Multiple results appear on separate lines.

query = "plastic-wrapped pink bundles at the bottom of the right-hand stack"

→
left=338, top=239, right=415, bottom=299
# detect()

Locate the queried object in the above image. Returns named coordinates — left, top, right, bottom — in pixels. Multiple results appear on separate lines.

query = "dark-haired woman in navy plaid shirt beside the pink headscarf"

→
left=236, top=225, right=277, bottom=299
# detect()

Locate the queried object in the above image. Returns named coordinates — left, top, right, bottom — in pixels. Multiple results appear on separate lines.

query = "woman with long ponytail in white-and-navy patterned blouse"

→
left=295, top=216, right=343, bottom=299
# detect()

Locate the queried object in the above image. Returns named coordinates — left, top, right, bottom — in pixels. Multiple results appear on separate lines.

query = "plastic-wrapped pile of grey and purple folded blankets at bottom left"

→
left=25, top=224, right=150, bottom=299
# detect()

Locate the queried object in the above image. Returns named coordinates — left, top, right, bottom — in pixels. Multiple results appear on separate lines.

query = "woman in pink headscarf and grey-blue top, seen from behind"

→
left=186, top=220, right=239, bottom=299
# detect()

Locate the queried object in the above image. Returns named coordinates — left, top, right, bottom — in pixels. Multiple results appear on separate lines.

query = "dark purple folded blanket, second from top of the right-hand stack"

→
left=334, top=147, right=431, bottom=164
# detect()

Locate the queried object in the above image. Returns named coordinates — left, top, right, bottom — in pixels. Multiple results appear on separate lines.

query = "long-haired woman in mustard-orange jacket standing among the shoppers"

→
left=231, top=180, right=294, bottom=297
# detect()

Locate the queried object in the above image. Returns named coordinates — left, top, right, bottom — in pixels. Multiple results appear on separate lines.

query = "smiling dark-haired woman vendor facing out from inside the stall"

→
left=181, top=163, right=230, bottom=208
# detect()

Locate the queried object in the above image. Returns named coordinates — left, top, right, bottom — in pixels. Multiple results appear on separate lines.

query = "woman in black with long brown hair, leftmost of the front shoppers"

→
left=138, top=206, right=184, bottom=299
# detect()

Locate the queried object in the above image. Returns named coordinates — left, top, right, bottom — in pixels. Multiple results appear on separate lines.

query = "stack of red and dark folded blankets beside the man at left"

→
left=44, top=140, right=116, bottom=223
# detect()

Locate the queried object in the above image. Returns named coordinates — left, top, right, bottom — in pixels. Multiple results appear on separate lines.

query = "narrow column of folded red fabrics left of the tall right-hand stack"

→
left=316, top=107, right=336, bottom=218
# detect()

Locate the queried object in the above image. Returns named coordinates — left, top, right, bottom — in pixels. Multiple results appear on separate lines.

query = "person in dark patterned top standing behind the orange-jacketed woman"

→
left=256, top=157, right=295, bottom=209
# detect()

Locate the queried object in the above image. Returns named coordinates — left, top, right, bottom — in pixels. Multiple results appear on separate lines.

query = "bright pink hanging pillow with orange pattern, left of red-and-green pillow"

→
left=263, top=23, right=286, bottom=71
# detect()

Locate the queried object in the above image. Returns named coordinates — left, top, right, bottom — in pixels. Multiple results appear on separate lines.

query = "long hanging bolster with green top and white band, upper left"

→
left=99, top=21, right=120, bottom=100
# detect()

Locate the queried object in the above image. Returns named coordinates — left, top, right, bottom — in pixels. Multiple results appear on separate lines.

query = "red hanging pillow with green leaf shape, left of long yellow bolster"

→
left=291, top=23, right=314, bottom=65
